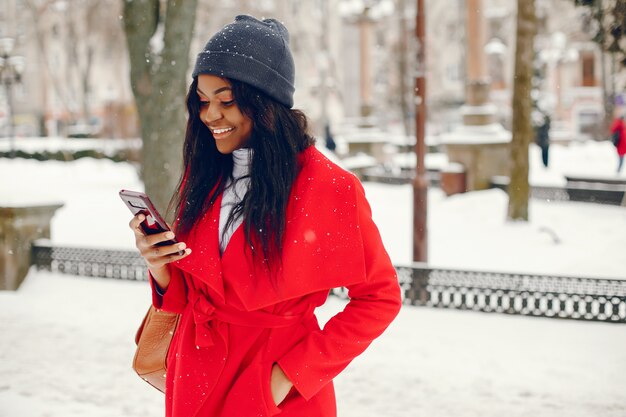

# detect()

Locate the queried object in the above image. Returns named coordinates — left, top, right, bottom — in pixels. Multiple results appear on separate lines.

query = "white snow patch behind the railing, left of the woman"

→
left=0, top=158, right=143, bottom=248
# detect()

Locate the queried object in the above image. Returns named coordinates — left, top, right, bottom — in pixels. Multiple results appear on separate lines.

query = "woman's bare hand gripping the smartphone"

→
left=129, top=214, right=191, bottom=290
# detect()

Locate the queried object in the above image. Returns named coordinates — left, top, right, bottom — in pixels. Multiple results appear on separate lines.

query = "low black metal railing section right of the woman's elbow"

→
left=396, top=264, right=626, bottom=323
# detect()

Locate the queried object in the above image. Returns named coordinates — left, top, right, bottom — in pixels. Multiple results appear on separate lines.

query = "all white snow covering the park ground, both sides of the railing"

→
left=0, top=139, right=626, bottom=417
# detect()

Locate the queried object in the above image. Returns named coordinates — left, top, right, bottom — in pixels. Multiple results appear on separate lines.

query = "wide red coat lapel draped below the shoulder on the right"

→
left=222, top=147, right=366, bottom=310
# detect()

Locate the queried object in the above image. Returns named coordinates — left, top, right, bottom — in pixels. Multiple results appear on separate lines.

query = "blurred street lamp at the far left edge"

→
left=0, top=38, right=24, bottom=158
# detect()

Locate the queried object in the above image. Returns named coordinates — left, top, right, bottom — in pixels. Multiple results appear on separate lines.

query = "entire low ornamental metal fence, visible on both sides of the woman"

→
left=32, top=242, right=626, bottom=323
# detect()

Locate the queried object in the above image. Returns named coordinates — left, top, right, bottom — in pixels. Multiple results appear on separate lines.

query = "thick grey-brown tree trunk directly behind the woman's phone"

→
left=124, top=0, right=198, bottom=213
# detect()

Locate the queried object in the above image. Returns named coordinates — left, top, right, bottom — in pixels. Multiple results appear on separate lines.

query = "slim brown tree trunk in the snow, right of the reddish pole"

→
left=508, top=0, right=536, bottom=221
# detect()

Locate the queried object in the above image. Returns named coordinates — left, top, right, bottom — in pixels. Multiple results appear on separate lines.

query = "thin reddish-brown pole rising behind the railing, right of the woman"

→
left=413, top=0, right=428, bottom=262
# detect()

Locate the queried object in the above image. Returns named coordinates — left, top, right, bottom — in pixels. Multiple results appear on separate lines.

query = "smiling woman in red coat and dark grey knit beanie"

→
left=130, top=16, right=401, bottom=417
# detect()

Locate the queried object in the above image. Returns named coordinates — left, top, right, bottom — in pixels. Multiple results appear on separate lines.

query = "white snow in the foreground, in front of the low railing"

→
left=0, top=271, right=626, bottom=417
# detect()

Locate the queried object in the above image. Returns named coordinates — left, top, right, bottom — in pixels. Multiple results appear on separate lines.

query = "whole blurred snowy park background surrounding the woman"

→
left=0, top=0, right=626, bottom=417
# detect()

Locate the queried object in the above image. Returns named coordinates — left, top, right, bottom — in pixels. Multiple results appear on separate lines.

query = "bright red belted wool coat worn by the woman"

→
left=153, top=147, right=401, bottom=417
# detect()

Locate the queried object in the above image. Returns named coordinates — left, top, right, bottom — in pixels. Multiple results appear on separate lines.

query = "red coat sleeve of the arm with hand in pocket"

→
left=278, top=180, right=402, bottom=400
